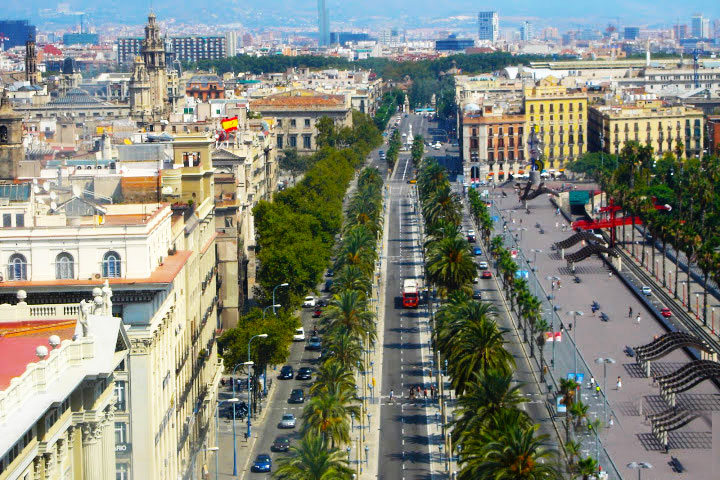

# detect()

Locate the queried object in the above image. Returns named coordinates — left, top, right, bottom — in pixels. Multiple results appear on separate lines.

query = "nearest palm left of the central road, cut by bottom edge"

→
left=273, top=433, right=354, bottom=480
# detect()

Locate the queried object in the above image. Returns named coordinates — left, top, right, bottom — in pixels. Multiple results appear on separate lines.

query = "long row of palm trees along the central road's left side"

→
left=274, top=168, right=383, bottom=480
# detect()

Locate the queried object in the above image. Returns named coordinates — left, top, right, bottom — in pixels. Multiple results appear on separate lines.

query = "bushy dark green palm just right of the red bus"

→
left=426, top=238, right=477, bottom=296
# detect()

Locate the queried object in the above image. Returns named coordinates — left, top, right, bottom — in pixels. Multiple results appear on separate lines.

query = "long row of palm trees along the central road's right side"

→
left=417, top=159, right=562, bottom=480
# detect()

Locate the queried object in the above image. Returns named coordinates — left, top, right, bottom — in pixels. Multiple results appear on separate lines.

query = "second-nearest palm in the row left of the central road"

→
left=303, top=390, right=360, bottom=448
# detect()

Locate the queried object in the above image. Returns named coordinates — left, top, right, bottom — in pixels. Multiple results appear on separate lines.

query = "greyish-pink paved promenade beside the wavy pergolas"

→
left=496, top=184, right=720, bottom=479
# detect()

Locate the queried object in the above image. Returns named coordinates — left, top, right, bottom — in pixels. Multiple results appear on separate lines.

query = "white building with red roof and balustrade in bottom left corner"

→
left=0, top=284, right=131, bottom=480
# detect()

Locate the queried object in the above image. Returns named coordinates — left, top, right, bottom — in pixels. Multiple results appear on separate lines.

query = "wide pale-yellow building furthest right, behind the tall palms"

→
left=588, top=100, right=704, bottom=157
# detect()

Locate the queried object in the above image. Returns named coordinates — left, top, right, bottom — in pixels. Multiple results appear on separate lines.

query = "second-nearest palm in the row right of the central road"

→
left=452, top=369, right=527, bottom=444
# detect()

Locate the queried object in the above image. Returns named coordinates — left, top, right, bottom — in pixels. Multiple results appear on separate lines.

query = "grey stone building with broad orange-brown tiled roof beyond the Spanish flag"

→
left=250, top=90, right=352, bottom=153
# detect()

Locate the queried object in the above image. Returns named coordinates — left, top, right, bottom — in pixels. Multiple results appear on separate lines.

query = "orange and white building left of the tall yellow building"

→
left=460, top=104, right=527, bottom=183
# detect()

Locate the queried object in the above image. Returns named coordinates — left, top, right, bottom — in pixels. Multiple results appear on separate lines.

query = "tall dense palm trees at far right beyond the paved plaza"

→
left=597, top=142, right=720, bottom=324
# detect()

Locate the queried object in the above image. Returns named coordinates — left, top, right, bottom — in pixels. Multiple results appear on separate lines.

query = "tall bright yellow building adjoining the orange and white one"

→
left=525, top=77, right=588, bottom=168
